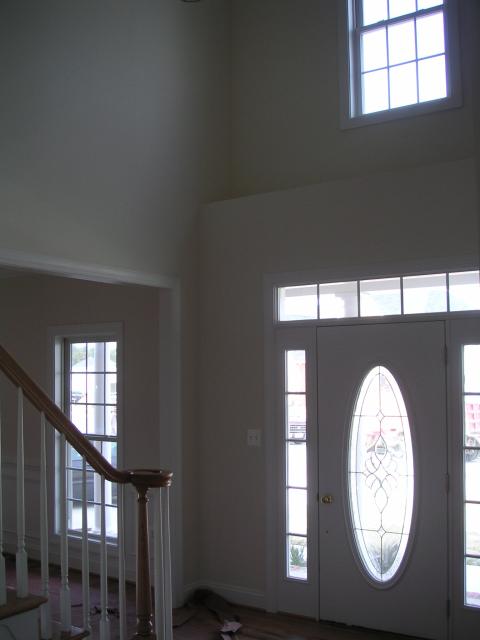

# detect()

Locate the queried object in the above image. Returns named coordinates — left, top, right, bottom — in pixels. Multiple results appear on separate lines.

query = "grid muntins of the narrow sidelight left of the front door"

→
left=283, top=350, right=308, bottom=582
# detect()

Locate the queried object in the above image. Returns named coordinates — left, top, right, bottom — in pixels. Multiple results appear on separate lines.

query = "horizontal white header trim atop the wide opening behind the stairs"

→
left=0, top=249, right=177, bottom=289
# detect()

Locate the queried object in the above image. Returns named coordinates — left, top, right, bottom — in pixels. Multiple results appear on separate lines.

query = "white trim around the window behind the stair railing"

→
left=49, top=323, right=124, bottom=547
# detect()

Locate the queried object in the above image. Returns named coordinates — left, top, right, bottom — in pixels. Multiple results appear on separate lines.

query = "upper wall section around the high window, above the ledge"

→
left=232, top=0, right=478, bottom=196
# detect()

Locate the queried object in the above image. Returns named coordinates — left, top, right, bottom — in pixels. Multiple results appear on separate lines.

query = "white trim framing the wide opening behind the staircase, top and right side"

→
left=0, top=249, right=184, bottom=607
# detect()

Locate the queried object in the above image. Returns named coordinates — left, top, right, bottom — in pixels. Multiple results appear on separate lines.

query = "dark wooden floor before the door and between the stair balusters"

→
left=7, top=558, right=424, bottom=640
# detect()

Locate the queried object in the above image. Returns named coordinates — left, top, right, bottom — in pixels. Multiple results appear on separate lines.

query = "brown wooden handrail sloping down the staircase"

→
left=0, top=346, right=172, bottom=488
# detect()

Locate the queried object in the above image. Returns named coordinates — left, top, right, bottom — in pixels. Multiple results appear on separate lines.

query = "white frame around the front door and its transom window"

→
left=263, top=255, right=480, bottom=628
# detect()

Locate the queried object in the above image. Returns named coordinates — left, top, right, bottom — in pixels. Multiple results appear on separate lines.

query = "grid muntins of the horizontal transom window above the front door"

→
left=274, top=269, right=480, bottom=323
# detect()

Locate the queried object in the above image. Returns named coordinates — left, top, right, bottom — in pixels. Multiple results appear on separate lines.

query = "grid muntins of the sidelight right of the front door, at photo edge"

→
left=462, top=344, right=480, bottom=609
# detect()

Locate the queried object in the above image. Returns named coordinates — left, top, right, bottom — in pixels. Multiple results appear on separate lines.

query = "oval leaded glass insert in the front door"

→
left=348, top=366, right=414, bottom=584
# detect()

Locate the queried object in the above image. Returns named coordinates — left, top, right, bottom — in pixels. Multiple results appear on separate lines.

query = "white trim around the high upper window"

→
left=337, top=0, right=463, bottom=129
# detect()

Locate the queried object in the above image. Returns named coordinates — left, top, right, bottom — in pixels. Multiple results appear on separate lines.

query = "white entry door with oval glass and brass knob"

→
left=316, top=322, right=447, bottom=640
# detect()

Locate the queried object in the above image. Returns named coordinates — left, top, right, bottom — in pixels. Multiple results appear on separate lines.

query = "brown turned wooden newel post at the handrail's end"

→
left=130, top=469, right=172, bottom=640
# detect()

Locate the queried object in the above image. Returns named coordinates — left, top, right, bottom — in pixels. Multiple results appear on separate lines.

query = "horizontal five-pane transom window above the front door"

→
left=275, top=270, right=480, bottom=322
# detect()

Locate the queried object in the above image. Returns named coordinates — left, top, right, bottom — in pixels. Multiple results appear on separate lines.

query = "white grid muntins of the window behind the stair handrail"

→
left=64, top=336, right=118, bottom=540
